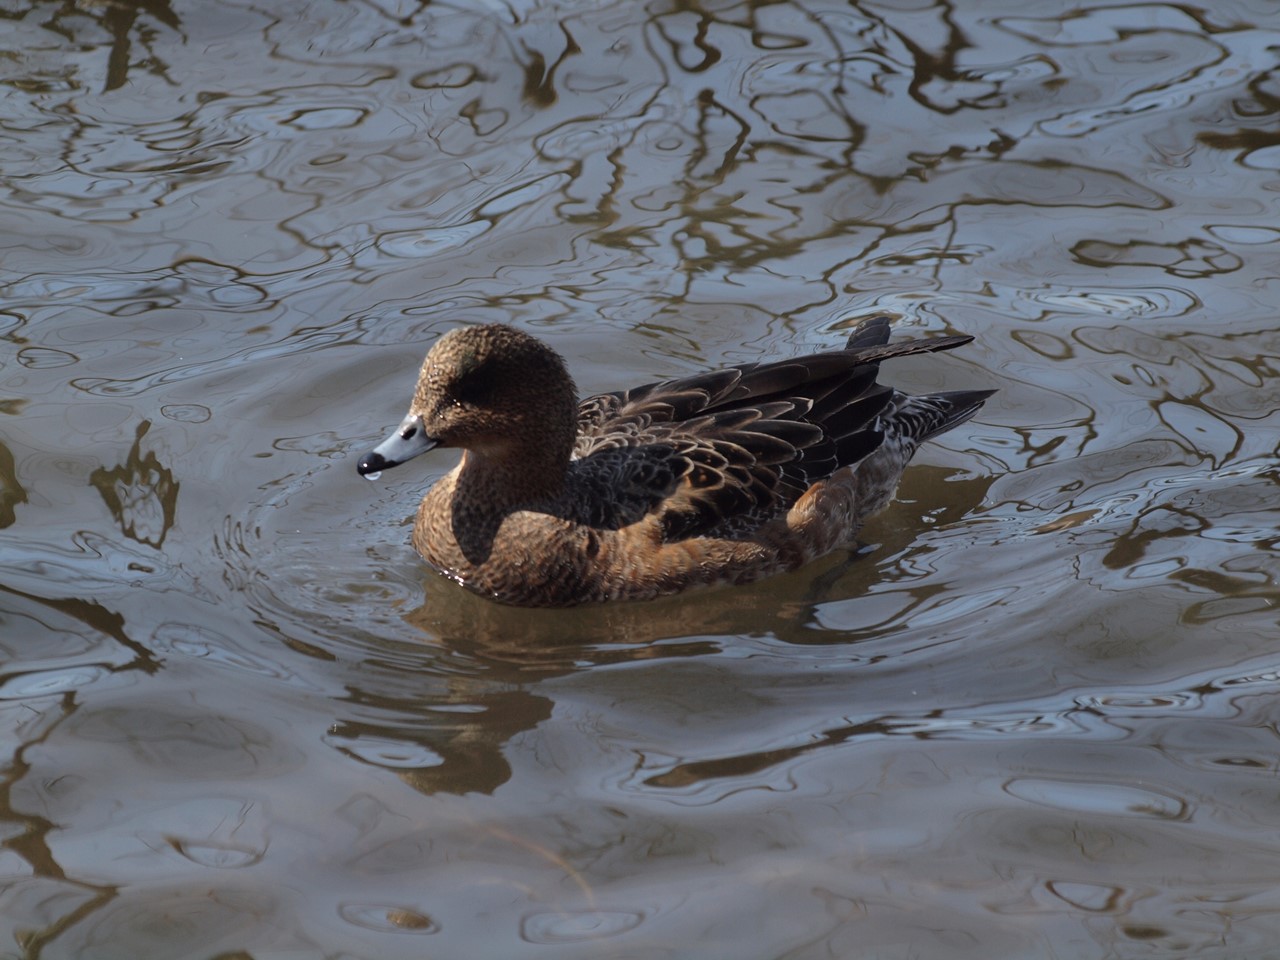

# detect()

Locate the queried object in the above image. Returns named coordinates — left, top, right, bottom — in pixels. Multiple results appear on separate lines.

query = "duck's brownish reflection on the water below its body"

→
left=332, top=466, right=989, bottom=794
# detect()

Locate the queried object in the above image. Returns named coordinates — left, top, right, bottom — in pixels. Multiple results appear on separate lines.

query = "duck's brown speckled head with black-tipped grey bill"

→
left=357, top=324, right=577, bottom=476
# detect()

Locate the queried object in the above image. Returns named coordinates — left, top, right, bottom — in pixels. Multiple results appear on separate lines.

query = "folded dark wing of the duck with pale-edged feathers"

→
left=571, top=317, right=970, bottom=541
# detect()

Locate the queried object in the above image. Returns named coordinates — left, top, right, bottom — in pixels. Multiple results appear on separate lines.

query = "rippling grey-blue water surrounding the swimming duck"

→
left=0, top=0, right=1280, bottom=960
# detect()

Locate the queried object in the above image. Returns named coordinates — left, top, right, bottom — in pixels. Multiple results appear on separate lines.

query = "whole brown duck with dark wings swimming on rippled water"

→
left=357, top=323, right=995, bottom=607
